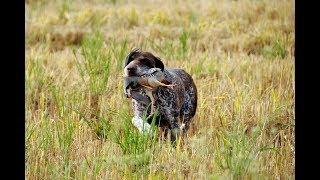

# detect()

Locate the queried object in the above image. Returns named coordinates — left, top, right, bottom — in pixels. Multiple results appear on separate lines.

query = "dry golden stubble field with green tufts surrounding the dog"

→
left=25, top=0, right=295, bottom=179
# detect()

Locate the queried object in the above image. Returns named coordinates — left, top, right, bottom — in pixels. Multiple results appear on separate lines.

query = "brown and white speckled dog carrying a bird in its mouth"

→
left=124, top=48, right=197, bottom=141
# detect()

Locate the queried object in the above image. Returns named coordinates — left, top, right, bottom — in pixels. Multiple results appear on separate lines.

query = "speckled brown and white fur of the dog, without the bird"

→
left=125, top=50, right=197, bottom=141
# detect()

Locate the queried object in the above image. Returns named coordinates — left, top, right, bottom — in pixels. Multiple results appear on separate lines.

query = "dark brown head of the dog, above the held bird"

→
left=124, top=48, right=164, bottom=77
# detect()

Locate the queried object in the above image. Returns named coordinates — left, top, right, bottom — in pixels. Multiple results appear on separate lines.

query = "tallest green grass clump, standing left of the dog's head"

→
left=76, top=31, right=110, bottom=118
